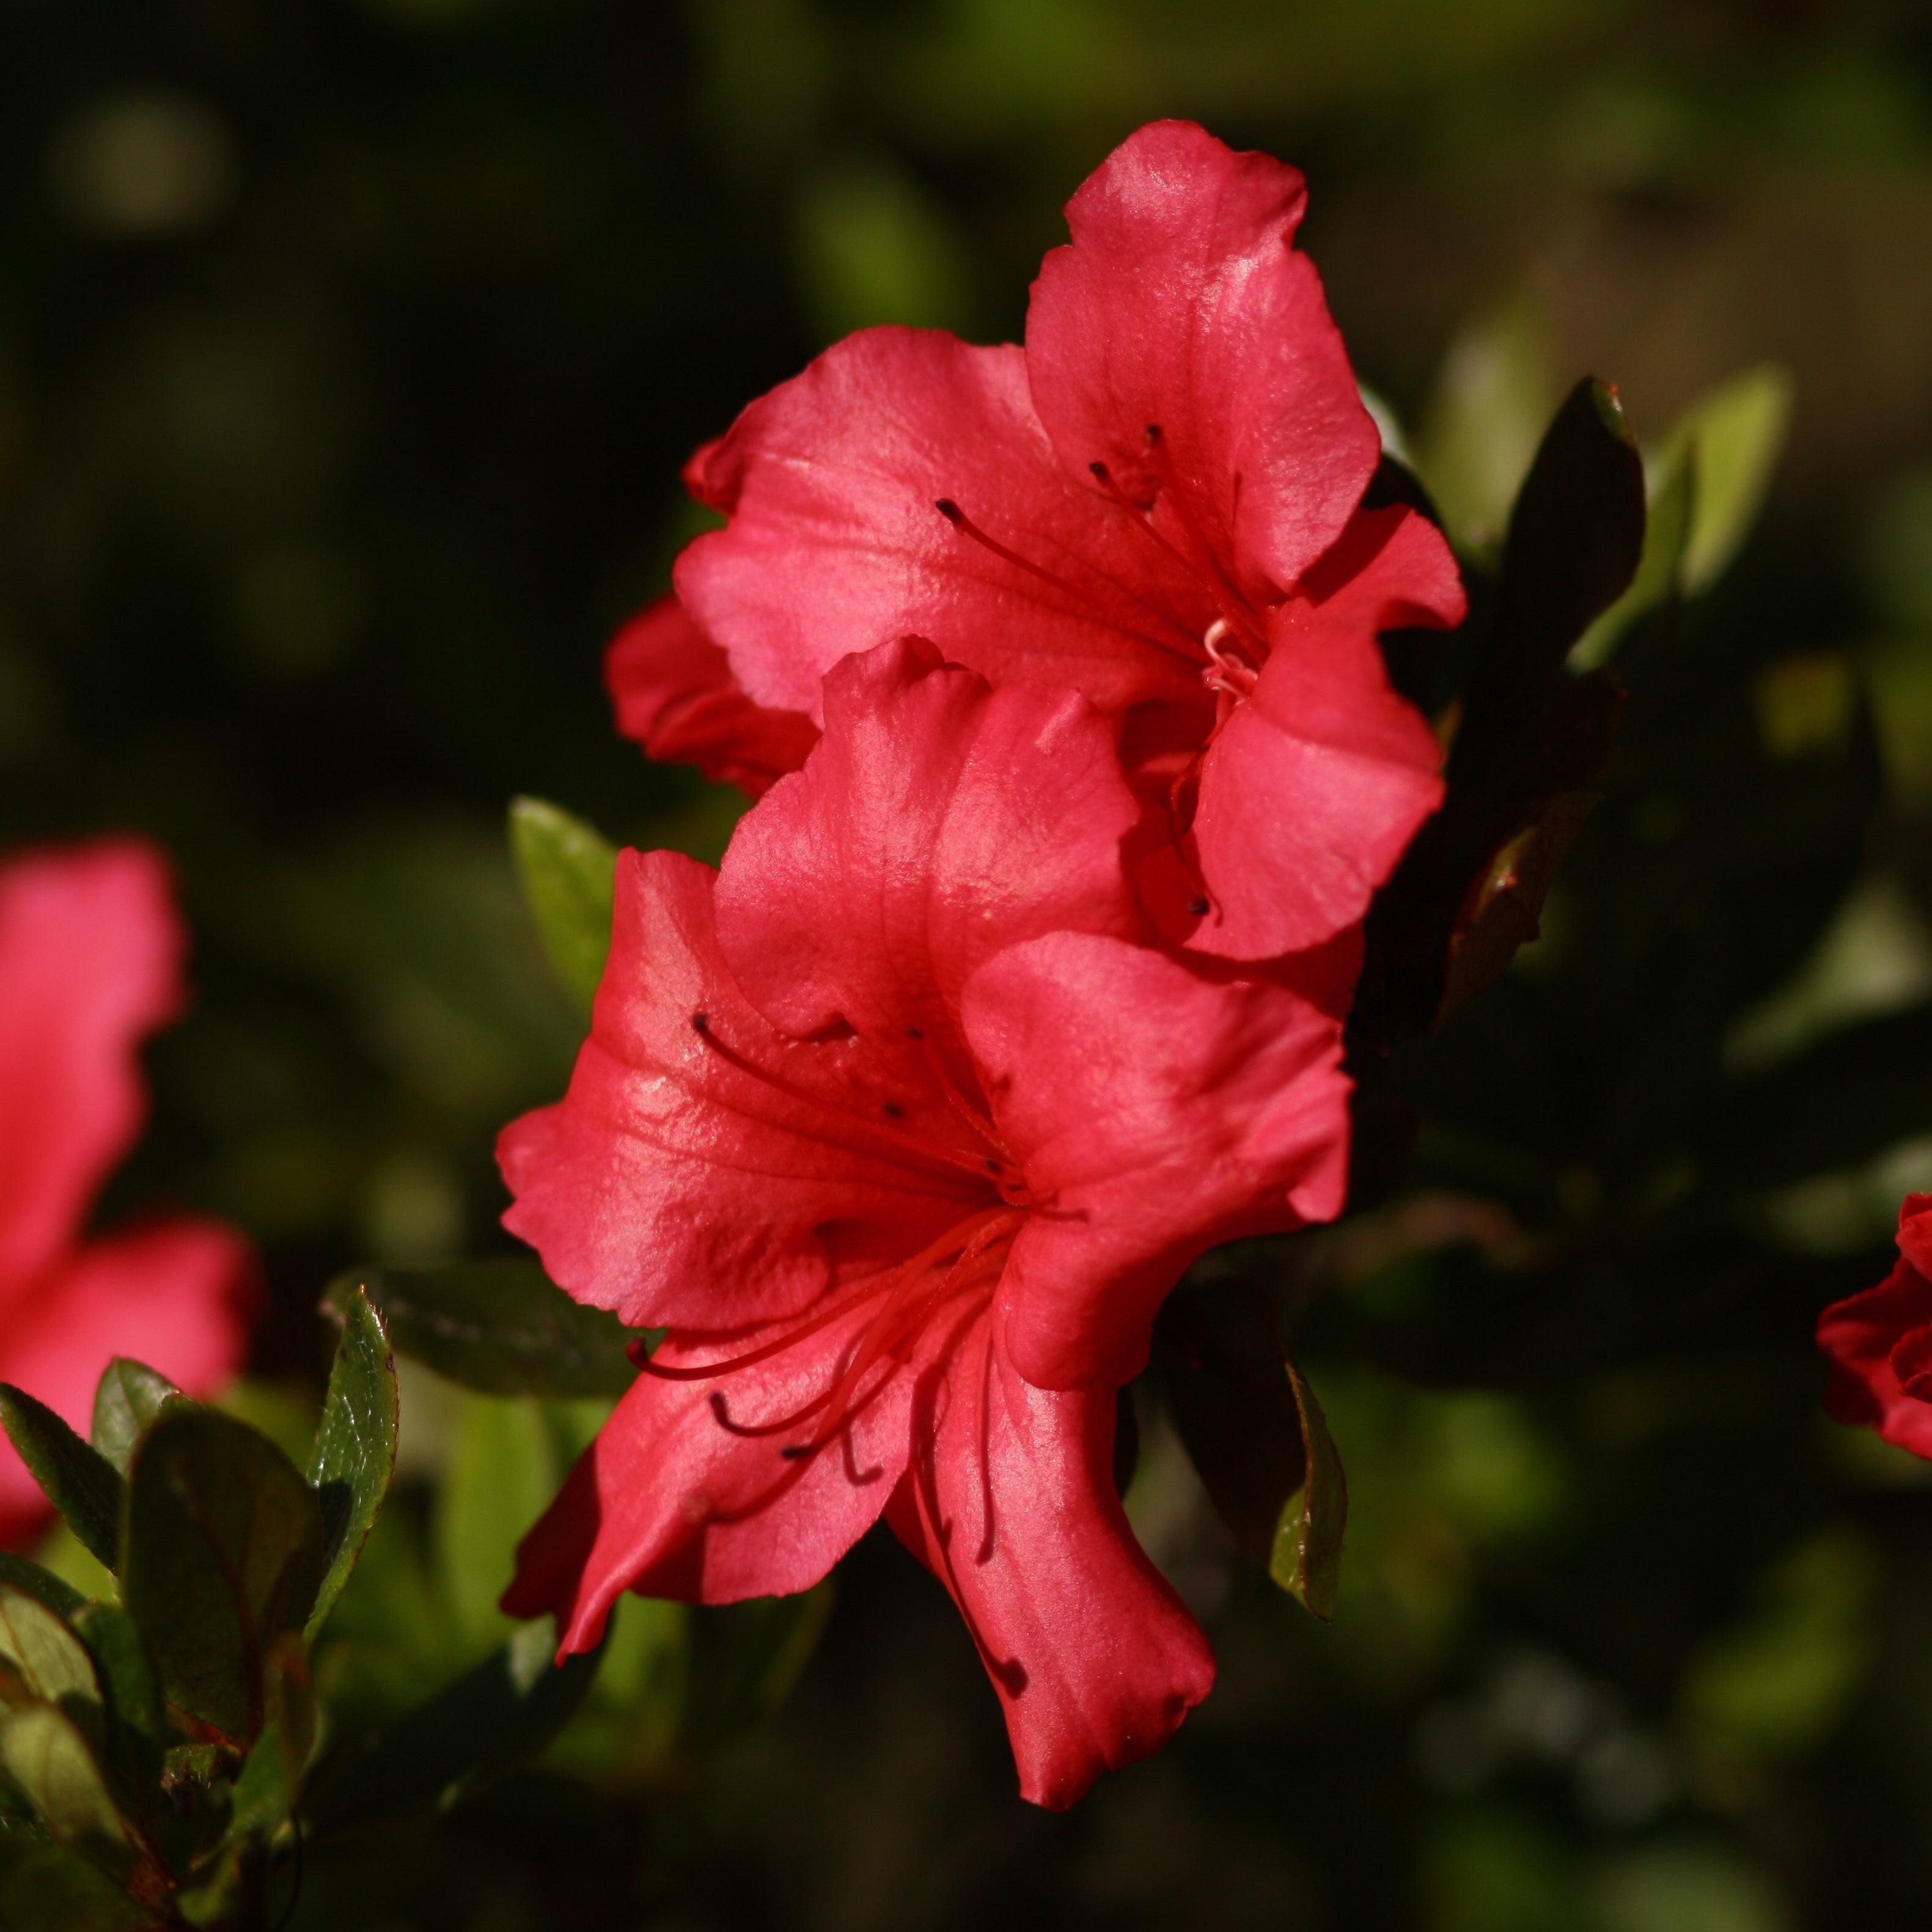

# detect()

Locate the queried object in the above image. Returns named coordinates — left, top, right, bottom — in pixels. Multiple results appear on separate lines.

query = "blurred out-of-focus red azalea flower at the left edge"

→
left=0, top=842, right=253, bottom=1549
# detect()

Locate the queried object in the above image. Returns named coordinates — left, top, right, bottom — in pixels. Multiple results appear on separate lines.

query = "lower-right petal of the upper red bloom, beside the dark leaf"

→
left=1188, top=510, right=1461, bottom=960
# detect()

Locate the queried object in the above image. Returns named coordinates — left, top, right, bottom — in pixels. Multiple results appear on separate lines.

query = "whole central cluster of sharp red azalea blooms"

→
left=501, top=122, right=1463, bottom=1807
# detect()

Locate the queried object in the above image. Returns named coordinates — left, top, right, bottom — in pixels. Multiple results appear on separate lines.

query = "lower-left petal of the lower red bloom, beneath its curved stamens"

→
left=504, top=1302, right=912, bottom=1654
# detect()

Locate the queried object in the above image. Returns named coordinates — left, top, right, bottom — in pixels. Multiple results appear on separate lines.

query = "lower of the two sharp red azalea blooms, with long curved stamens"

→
left=499, top=639, right=1346, bottom=1804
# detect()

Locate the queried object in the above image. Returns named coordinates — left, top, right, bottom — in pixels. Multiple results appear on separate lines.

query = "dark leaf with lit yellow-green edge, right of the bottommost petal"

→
left=1153, top=1281, right=1348, bottom=1623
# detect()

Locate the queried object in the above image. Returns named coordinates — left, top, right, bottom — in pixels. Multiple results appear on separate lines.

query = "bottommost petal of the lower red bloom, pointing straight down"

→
left=887, top=1313, right=1213, bottom=1810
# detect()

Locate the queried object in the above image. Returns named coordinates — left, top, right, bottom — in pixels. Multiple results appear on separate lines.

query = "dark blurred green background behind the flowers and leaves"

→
left=11, top=0, right=1932, bottom=1932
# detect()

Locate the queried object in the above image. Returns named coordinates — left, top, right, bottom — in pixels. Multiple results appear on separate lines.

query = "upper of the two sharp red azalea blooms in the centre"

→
left=676, top=122, right=1464, bottom=960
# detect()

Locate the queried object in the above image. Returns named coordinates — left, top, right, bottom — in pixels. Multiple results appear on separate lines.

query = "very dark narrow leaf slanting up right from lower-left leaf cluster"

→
left=307, top=1617, right=599, bottom=1837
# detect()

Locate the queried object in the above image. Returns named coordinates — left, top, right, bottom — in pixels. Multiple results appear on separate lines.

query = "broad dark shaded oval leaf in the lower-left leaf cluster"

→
left=122, top=1406, right=323, bottom=1741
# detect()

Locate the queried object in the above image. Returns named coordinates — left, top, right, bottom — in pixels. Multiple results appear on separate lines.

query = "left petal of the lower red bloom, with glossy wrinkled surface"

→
left=496, top=852, right=983, bottom=1329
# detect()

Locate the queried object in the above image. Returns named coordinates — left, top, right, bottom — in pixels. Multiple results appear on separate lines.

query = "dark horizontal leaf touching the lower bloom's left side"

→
left=323, top=1258, right=641, bottom=1397
